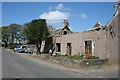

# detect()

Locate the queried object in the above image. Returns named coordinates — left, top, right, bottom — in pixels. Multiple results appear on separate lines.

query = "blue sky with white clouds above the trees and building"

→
left=2, top=2, right=115, bottom=32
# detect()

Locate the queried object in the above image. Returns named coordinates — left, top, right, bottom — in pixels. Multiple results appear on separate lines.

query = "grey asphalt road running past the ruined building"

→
left=2, top=49, right=118, bottom=78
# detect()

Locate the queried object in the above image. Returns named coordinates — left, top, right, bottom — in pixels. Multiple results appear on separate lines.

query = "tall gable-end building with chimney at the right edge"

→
left=106, top=2, right=120, bottom=63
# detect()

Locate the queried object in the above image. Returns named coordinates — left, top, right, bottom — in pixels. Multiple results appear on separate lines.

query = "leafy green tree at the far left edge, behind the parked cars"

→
left=2, top=24, right=21, bottom=44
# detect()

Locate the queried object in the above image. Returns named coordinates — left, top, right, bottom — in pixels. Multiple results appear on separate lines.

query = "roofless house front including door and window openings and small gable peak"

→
left=55, top=22, right=107, bottom=58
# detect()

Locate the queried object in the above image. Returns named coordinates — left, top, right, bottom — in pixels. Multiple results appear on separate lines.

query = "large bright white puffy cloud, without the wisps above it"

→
left=40, top=10, right=70, bottom=23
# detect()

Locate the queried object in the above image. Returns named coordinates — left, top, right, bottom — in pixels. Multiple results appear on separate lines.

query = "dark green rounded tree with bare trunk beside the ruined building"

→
left=24, top=19, right=49, bottom=55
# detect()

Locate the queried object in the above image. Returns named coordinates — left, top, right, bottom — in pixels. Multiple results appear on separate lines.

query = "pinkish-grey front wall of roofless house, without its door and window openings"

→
left=56, top=29, right=106, bottom=58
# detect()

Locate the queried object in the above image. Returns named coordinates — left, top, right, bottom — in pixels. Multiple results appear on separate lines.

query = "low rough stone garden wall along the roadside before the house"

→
left=47, top=56, right=108, bottom=68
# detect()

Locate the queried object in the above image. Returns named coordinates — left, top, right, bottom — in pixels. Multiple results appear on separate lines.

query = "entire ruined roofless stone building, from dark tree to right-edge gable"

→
left=42, top=3, right=120, bottom=63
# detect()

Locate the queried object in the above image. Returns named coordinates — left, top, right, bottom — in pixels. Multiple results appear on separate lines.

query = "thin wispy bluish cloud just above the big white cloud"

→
left=48, top=3, right=71, bottom=11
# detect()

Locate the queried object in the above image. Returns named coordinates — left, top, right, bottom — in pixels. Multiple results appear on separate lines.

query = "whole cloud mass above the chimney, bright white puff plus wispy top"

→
left=40, top=3, right=71, bottom=24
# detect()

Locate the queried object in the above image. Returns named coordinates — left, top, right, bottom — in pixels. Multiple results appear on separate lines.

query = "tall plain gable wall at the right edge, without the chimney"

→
left=106, top=10, right=120, bottom=64
